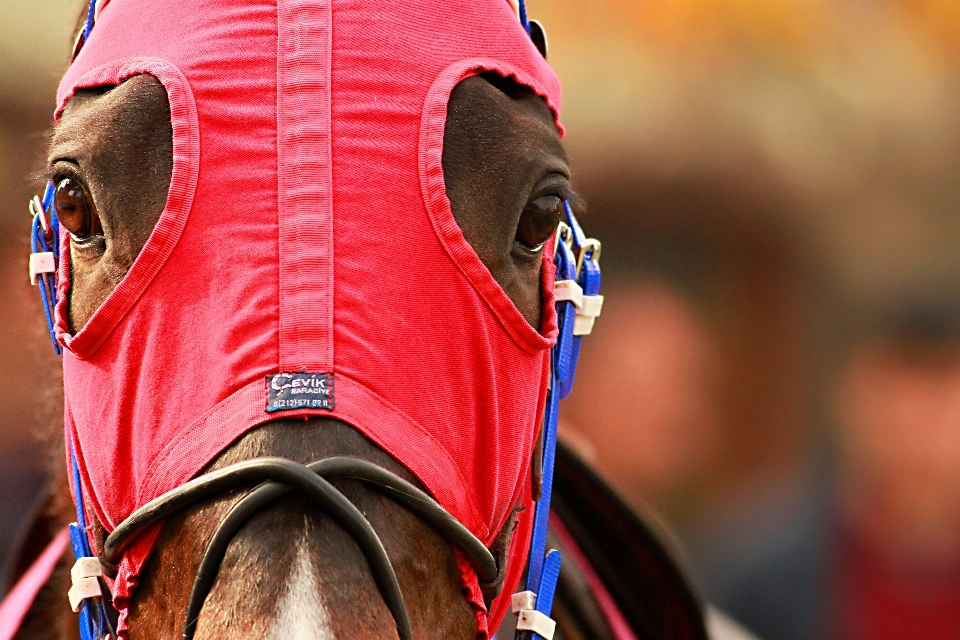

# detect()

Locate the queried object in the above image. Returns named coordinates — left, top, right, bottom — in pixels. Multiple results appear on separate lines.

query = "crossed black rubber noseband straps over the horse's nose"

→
left=101, top=456, right=500, bottom=640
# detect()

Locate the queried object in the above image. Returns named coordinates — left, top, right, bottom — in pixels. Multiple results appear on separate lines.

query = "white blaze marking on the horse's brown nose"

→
left=271, top=542, right=336, bottom=640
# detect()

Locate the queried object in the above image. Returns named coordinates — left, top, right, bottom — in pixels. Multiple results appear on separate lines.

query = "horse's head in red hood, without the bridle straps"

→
left=35, top=0, right=577, bottom=639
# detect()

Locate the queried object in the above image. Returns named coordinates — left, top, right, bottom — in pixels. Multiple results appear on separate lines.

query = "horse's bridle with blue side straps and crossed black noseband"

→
left=30, top=0, right=603, bottom=640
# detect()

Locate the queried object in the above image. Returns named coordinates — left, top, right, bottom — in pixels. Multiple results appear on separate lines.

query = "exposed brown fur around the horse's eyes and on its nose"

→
left=11, top=67, right=576, bottom=640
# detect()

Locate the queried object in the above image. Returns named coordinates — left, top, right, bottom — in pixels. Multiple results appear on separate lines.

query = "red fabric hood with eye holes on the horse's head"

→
left=57, top=0, right=560, bottom=628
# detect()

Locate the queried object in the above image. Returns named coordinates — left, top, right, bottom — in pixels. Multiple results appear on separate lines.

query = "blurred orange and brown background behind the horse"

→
left=0, top=0, right=960, bottom=640
